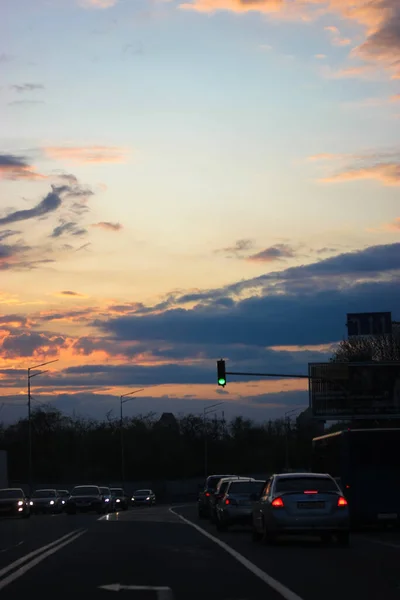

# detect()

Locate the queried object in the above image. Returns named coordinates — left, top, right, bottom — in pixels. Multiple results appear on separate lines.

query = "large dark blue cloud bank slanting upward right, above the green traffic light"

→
left=94, top=244, right=400, bottom=355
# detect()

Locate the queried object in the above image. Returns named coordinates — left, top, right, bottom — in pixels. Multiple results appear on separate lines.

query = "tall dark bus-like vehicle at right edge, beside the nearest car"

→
left=311, top=428, right=400, bottom=527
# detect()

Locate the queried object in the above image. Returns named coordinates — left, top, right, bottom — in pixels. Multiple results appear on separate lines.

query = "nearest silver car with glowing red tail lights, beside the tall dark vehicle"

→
left=252, top=473, right=350, bottom=546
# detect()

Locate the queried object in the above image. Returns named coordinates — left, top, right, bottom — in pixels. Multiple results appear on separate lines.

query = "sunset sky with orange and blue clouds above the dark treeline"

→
left=0, top=0, right=400, bottom=422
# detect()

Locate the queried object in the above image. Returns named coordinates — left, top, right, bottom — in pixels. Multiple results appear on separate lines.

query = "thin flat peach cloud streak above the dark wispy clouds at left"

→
left=44, top=146, right=127, bottom=164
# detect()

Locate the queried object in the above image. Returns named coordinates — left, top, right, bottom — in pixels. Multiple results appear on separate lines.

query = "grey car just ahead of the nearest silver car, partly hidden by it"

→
left=215, top=478, right=265, bottom=531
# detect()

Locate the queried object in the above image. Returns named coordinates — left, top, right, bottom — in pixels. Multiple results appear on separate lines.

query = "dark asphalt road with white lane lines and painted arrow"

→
left=0, top=505, right=400, bottom=600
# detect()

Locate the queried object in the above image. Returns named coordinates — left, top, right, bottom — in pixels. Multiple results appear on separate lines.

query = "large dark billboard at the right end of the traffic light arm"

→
left=308, top=362, right=400, bottom=420
